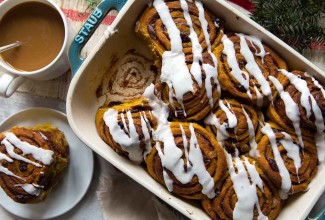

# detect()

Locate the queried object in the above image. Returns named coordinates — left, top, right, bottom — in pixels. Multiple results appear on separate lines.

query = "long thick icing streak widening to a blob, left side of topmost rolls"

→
left=153, top=0, right=194, bottom=116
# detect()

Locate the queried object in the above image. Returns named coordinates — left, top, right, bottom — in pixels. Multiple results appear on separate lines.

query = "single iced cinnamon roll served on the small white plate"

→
left=0, top=125, right=69, bottom=203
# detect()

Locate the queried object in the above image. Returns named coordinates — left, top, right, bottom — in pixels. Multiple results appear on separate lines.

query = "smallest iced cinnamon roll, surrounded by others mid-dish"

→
left=204, top=99, right=263, bottom=157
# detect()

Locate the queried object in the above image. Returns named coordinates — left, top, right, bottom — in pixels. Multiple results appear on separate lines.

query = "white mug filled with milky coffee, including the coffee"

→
left=0, top=0, right=71, bottom=97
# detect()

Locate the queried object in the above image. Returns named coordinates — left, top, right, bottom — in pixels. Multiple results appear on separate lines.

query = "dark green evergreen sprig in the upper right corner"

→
left=251, top=0, right=325, bottom=52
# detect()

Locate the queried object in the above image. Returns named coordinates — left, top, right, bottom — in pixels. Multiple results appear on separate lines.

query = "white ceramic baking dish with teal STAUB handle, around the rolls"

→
left=67, top=0, right=325, bottom=220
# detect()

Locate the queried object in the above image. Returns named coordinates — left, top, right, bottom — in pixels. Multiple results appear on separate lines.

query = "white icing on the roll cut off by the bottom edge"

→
left=225, top=153, right=268, bottom=220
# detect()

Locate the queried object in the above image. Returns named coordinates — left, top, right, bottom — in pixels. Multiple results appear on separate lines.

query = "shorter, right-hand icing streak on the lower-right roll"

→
left=280, top=132, right=301, bottom=183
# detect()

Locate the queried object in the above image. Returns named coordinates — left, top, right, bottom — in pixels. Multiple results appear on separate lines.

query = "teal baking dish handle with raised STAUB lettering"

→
left=68, top=0, right=127, bottom=76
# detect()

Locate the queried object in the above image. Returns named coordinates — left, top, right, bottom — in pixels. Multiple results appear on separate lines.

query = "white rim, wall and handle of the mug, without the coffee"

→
left=0, top=0, right=72, bottom=97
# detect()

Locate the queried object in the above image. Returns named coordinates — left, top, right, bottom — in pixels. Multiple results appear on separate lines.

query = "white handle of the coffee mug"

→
left=0, top=73, right=26, bottom=98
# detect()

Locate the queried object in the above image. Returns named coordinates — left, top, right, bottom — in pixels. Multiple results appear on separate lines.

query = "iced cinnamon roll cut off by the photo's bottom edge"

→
left=202, top=155, right=283, bottom=220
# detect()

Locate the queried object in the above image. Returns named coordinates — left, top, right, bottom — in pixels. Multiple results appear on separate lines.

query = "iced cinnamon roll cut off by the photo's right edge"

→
left=267, top=70, right=325, bottom=161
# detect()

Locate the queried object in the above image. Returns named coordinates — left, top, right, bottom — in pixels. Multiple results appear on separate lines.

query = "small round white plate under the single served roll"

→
left=0, top=108, right=94, bottom=219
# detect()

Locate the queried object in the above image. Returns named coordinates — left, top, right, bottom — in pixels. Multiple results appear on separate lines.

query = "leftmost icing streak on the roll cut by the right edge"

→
left=269, top=76, right=304, bottom=147
